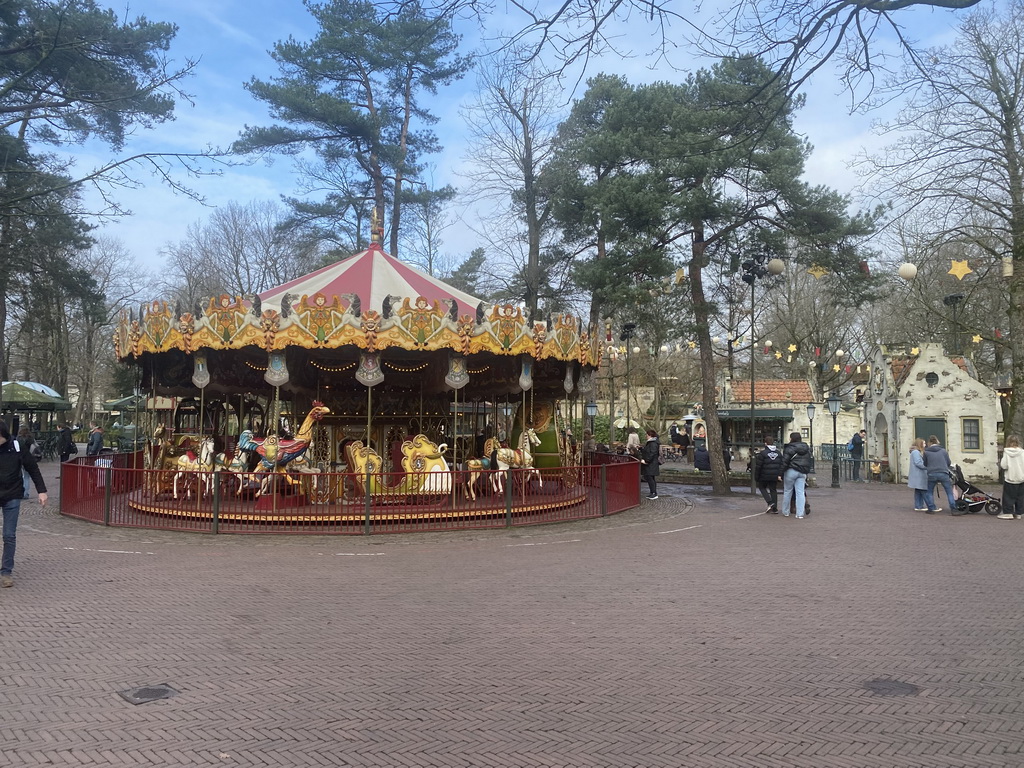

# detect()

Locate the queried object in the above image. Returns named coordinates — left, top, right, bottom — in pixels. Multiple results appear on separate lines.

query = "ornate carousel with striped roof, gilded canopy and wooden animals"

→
left=115, top=219, right=601, bottom=521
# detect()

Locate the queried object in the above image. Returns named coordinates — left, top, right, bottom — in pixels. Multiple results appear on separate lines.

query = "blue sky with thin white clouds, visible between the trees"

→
left=75, top=0, right=974, bottom=270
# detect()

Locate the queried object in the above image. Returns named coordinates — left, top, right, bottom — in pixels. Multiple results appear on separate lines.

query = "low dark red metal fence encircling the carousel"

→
left=60, top=454, right=640, bottom=535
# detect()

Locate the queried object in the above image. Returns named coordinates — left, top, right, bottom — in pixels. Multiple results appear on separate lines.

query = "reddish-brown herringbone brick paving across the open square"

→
left=0, top=464, right=1024, bottom=768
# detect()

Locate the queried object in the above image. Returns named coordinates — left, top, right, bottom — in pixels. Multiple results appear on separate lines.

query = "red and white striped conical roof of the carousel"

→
left=259, top=243, right=480, bottom=314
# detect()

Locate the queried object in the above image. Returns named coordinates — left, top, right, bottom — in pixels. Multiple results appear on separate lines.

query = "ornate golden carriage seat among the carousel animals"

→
left=345, top=434, right=452, bottom=497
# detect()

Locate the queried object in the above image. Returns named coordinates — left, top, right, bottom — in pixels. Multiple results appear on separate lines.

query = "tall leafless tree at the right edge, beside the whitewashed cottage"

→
left=865, top=0, right=1024, bottom=433
